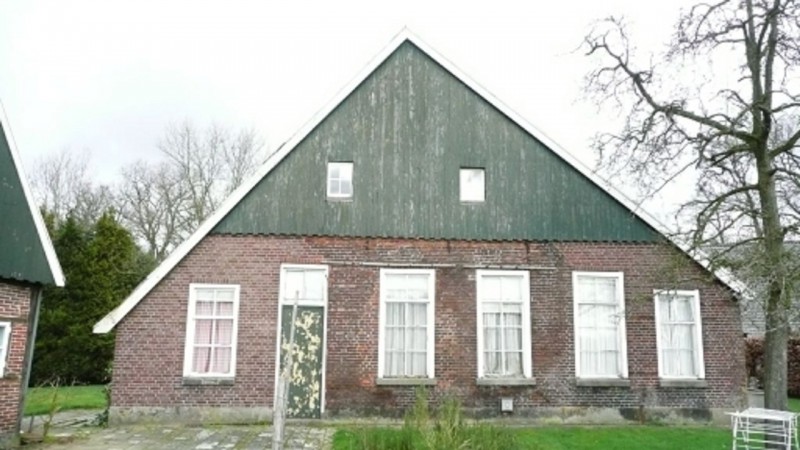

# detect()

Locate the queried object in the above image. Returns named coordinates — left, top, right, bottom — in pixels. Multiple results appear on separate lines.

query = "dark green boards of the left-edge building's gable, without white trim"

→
left=0, top=124, right=55, bottom=284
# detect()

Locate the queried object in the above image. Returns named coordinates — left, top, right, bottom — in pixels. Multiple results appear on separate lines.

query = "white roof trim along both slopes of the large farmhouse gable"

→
left=94, top=29, right=745, bottom=333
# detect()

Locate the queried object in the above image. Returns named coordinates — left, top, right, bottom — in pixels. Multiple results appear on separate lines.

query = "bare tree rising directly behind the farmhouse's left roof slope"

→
left=117, top=121, right=264, bottom=261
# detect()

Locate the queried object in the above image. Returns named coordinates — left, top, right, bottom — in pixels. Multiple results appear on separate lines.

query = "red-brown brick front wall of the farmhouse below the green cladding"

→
left=112, top=235, right=745, bottom=415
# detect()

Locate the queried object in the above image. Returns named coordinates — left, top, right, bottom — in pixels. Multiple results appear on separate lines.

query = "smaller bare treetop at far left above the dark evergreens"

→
left=31, top=149, right=114, bottom=223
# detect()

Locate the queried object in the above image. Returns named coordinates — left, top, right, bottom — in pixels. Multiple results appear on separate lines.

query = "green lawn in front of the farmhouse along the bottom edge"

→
left=333, top=425, right=731, bottom=450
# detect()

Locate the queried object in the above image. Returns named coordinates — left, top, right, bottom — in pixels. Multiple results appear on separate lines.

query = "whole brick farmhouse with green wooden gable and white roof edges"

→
left=95, top=32, right=745, bottom=422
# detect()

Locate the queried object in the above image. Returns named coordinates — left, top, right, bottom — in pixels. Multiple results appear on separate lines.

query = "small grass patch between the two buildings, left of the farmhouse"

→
left=25, top=385, right=106, bottom=416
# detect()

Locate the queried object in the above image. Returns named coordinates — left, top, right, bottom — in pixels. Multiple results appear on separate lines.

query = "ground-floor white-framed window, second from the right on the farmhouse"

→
left=572, top=272, right=628, bottom=379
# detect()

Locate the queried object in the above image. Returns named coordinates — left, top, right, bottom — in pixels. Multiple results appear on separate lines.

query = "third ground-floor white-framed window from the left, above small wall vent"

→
left=475, top=270, right=532, bottom=378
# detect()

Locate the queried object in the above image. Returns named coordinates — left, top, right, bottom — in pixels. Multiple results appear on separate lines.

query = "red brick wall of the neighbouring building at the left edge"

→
left=0, top=279, right=31, bottom=446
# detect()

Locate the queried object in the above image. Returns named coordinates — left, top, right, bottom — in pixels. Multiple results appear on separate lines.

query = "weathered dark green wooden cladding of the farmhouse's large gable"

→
left=213, top=42, right=659, bottom=241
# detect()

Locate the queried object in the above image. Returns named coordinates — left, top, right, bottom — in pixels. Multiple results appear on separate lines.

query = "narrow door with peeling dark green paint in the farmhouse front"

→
left=280, top=305, right=325, bottom=419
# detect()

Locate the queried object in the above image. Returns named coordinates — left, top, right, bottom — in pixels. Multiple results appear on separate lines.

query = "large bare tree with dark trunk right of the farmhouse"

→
left=585, top=0, right=800, bottom=409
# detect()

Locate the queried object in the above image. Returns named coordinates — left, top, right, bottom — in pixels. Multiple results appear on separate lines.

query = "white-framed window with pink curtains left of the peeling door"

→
left=191, top=287, right=238, bottom=376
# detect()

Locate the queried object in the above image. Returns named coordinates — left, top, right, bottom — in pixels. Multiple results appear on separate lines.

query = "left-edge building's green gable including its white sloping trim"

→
left=0, top=105, right=64, bottom=286
